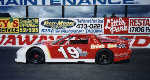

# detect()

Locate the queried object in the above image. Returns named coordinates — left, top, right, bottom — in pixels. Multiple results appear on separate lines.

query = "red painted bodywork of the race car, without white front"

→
left=46, top=34, right=132, bottom=61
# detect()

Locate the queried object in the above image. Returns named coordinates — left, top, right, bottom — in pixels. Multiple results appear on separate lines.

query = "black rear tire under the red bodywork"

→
left=95, top=51, right=113, bottom=65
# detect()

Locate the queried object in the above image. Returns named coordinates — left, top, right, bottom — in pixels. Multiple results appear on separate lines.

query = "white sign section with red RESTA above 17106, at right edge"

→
left=128, top=18, right=150, bottom=34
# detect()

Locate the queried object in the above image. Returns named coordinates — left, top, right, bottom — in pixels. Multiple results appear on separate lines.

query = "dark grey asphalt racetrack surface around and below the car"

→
left=0, top=47, right=150, bottom=80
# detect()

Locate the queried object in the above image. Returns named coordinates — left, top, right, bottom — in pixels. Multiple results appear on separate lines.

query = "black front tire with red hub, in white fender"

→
left=26, top=47, right=45, bottom=64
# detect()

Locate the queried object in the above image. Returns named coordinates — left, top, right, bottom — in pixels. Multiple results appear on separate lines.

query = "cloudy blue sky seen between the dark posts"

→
left=0, top=5, right=150, bottom=18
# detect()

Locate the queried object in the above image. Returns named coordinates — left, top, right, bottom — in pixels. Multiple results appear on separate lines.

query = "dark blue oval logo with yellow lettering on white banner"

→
left=41, top=19, right=76, bottom=29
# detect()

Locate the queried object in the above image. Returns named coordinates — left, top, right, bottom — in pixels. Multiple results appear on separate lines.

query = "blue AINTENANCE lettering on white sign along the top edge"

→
left=0, top=0, right=136, bottom=6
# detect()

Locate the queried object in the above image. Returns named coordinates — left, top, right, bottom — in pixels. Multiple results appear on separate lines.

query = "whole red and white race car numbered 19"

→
left=15, top=34, right=132, bottom=64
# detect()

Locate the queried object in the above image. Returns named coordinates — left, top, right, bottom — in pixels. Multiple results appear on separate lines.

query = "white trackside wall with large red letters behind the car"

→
left=0, top=34, right=150, bottom=48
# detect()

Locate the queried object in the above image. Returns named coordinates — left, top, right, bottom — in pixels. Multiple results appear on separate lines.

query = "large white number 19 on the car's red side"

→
left=58, top=47, right=79, bottom=59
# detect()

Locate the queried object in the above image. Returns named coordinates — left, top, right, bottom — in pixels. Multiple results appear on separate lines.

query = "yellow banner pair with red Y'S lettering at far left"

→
left=0, top=17, right=39, bottom=34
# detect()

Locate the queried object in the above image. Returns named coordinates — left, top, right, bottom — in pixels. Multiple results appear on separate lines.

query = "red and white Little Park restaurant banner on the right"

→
left=104, top=17, right=150, bottom=34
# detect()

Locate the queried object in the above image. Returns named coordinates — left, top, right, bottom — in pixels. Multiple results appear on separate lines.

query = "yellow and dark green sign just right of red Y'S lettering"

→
left=19, top=18, right=39, bottom=33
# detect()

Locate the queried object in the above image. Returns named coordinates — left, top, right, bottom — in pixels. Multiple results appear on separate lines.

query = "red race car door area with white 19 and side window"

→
left=58, top=36, right=91, bottom=59
